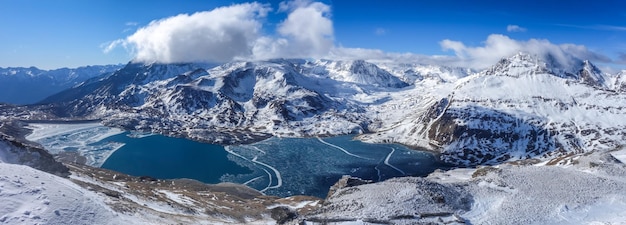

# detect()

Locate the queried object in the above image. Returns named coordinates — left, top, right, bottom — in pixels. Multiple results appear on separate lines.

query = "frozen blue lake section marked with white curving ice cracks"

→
left=221, top=136, right=440, bottom=197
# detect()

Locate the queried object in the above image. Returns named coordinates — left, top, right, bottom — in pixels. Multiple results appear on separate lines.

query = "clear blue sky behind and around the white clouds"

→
left=0, top=0, right=626, bottom=69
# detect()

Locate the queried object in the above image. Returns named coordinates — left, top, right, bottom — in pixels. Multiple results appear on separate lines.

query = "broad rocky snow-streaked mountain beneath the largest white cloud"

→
left=44, top=60, right=407, bottom=143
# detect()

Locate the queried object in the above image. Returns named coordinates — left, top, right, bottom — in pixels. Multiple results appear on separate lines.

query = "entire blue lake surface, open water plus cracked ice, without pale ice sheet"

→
left=102, top=134, right=445, bottom=197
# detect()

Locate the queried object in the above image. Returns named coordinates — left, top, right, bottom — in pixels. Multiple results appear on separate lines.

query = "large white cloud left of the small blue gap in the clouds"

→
left=104, top=3, right=270, bottom=63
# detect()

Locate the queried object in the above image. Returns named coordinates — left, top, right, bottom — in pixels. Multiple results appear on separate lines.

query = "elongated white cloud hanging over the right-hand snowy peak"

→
left=439, top=34, right=611, bottom=69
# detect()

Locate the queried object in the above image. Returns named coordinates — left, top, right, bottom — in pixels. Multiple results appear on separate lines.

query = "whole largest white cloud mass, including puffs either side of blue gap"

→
left=101, top=0, right=334, bottom=63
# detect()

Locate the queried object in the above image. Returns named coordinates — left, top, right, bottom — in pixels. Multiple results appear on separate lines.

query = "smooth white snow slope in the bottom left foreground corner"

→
left=0, top=163, right=132, bottom=224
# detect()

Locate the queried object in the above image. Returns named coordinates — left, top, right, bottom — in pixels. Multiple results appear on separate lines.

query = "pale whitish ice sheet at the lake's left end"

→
left=26, top=122, right=124, bottom=167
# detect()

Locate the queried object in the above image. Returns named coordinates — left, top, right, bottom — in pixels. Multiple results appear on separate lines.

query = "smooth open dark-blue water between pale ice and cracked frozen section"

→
left=101, top=133, right=253, bottom=183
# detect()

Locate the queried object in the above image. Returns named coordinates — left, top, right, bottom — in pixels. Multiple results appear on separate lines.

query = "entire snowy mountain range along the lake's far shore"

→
left=12, top=52, right=626, bottom=166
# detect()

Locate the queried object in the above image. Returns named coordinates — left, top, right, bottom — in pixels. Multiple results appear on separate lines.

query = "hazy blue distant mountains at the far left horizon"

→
left=0, top=65, right=121, bottom=104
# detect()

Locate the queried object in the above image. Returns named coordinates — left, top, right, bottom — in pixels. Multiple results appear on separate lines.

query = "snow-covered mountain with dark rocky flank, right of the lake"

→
left=356, top=53, right=626, bottom=165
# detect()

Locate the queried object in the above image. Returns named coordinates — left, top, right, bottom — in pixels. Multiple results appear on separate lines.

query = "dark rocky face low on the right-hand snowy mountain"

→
left=428, top=107, right=559, bottom=166
